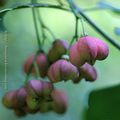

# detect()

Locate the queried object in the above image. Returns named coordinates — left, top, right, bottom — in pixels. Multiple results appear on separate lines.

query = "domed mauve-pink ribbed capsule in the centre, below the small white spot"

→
left=48, top=60, right=79, bottom=83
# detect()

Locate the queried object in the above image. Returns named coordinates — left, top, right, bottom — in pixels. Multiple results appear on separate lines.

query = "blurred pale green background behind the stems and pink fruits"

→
left=0, top=0, right=120, bottom=120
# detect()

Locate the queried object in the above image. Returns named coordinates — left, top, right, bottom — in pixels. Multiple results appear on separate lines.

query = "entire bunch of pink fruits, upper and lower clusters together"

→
left=3, top=36, right=109, bottom=116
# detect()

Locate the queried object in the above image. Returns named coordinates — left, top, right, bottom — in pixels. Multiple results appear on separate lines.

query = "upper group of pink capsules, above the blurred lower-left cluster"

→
left=24, top=36, right=109, bottom=83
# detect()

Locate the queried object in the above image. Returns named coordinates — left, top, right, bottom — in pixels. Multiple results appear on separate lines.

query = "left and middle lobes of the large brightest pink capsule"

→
left=70, top=36, right=97, bottom=67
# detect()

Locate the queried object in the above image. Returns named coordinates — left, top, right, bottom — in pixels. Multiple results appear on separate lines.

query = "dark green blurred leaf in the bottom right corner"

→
left=86, top=85, right=120, bottom=120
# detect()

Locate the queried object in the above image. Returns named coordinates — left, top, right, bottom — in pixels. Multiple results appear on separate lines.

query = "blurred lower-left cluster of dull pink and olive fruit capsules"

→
left=3, top=80, right=67, bottom=117
